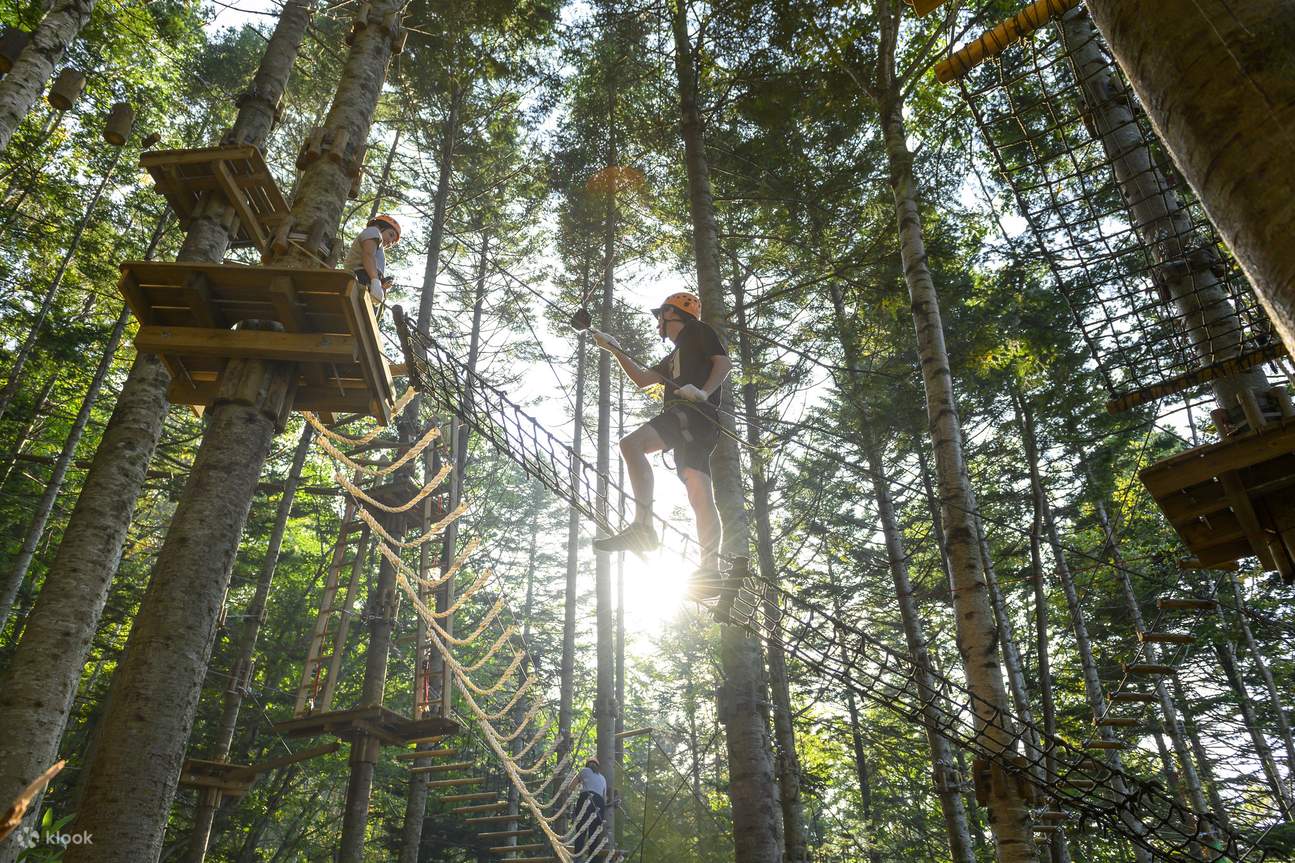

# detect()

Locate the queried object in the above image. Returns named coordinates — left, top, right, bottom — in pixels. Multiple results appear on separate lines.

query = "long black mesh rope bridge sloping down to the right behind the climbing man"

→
left=395, top=307, right=1279, bottom=860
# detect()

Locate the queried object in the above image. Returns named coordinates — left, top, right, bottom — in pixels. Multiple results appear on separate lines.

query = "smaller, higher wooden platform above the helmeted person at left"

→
left=140, top=145, right=289, bottom=251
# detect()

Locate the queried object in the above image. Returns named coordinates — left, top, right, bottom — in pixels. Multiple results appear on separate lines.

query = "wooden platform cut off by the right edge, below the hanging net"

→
left=1141, top=417, right=1295, bottom=582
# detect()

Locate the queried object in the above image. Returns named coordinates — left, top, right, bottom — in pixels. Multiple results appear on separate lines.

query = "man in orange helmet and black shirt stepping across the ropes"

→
left=591, top=292, right=733, bottom=600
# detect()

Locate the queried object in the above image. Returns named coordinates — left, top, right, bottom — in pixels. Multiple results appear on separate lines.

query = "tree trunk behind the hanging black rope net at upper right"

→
left=1061, top=9, right=1269, bottom=416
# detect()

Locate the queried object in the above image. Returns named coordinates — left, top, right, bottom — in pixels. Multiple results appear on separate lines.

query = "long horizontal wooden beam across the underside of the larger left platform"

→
left=135, top=327, right=355, bottom=363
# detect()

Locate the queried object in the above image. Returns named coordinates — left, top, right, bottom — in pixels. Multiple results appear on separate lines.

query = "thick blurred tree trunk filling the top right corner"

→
left=1088, top=0, right=1295, bottom=345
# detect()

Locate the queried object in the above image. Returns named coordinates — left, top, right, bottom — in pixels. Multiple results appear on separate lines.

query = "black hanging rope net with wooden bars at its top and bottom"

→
left=938, top=0, right=1286, bottom=412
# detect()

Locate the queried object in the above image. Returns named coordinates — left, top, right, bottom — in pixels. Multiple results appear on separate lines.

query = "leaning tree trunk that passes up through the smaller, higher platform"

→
left=0, top=0, right=311, bottom=863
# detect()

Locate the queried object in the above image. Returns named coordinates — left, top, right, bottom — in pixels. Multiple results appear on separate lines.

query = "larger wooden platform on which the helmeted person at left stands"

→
left=118, top=262, right=395, bottom=422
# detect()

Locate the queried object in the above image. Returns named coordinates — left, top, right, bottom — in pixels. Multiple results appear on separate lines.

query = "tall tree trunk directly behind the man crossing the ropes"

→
left=671, top=0, right=782, bottom=863
